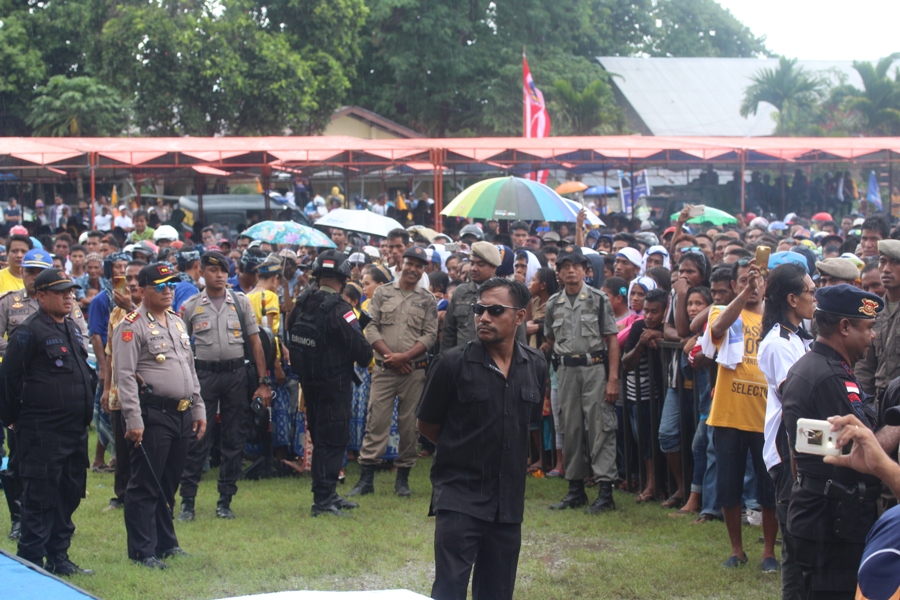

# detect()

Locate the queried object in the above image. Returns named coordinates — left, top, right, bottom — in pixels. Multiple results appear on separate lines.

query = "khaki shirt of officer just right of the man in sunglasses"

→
left=544, top=284, right=619, bottom=356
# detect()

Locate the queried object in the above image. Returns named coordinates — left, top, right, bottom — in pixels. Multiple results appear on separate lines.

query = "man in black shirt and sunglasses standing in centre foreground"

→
left=416, top=277, right=548, bottom=600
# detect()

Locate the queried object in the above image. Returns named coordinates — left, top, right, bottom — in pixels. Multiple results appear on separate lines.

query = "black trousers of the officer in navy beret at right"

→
left=793, top=536, right=865, bottom=600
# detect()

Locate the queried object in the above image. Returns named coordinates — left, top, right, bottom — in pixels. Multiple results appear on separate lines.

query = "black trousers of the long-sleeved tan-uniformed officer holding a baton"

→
left=125, top=406, right=191, bottom=560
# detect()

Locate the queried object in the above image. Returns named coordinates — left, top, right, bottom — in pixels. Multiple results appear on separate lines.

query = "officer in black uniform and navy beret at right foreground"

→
left=781, top=284, right=884, bottom=599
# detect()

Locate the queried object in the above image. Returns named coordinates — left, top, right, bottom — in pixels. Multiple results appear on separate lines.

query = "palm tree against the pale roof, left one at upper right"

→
left=741, top=56, right=823, bottom=135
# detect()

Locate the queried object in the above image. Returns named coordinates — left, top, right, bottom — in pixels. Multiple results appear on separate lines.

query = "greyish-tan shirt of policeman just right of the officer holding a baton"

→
left=181, top=291, right=259, bottom=361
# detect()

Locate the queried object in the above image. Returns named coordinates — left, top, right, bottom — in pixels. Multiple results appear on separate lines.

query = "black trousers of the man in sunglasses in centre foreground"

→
left=431, top=510, right=522, bottom=600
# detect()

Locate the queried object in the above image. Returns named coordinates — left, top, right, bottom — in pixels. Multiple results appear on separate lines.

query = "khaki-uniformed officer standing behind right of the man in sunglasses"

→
left=541, top=246, right=619, bottom=514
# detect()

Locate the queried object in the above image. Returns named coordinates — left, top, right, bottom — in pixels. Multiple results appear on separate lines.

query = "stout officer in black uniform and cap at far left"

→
left=0, top=269, right=96, bottom=575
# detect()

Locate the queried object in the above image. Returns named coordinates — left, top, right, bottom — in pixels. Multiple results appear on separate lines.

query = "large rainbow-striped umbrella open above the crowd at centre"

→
left=441, top=177, right=578, bottom=223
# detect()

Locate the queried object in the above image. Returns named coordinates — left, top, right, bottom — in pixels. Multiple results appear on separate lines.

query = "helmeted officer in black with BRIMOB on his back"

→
left=286, top=250, right=372, bottom=517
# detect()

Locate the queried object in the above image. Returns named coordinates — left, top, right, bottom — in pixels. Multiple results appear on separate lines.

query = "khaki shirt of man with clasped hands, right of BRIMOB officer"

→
left=366, top=281, right=437, bottom=360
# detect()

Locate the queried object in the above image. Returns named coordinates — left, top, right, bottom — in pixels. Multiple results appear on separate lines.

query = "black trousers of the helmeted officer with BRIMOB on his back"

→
left=303, top=383, right=353, bottom=508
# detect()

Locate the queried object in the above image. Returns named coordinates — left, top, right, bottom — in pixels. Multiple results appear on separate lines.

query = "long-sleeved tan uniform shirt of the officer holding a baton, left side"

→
left=112, top=305, right=206, bottom=429
